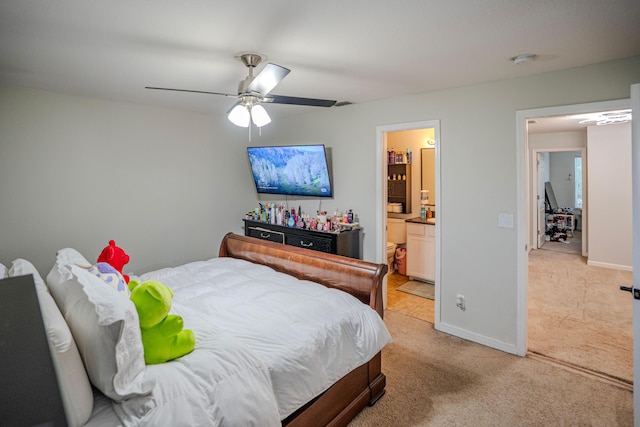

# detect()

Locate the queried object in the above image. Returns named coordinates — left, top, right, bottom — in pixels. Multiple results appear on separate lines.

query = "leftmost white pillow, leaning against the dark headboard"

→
left=9, top=258, right=93, bottom=426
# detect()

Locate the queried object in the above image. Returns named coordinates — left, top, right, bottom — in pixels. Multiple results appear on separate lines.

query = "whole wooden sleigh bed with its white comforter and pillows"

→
left=0, top=233, right=391, bottom=427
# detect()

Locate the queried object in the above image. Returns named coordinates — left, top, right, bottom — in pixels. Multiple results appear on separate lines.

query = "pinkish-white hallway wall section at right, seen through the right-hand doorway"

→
left=587, top=123, right=637, bottom=271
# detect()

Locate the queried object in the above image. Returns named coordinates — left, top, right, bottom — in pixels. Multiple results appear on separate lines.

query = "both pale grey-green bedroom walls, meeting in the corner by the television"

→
left=0, top=57, right=640, bottom=349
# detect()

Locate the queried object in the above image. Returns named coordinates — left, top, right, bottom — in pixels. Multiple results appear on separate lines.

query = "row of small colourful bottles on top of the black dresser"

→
left=245, top=203, right=353, bottom=233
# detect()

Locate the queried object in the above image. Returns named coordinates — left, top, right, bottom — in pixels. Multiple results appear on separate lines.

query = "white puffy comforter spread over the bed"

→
left=114, top=258, right=391, bottom=426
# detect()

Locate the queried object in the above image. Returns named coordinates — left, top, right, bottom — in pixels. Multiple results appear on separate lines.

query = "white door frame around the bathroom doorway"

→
left=376, top=120, right=443, bottom=329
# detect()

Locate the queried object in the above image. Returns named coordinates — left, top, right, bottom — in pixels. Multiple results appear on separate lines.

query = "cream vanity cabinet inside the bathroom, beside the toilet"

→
left=407, top=218, right=436, bottom=282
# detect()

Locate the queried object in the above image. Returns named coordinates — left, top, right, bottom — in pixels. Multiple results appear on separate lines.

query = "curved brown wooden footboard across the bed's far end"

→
left=218, top=233, right=388, bottom=317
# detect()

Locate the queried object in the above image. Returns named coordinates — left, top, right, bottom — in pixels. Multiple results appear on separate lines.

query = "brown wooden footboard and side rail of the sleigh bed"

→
left=219, top=233, right=388, bottom=427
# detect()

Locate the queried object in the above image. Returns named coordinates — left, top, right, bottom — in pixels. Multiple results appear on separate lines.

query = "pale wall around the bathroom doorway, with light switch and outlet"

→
left=258, top=58, right=640, bottom=352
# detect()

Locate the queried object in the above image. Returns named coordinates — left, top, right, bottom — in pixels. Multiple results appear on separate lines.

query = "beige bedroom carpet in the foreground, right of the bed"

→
left=349, top=311, right=633, bottom=427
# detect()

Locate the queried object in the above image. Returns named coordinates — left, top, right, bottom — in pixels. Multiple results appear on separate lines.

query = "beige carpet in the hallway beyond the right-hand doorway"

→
left=528, top=247, right=633, bottom=383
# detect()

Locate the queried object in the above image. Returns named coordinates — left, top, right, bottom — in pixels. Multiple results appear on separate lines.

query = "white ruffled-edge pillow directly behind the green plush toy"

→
left=63, top=265, right=155, bottom=401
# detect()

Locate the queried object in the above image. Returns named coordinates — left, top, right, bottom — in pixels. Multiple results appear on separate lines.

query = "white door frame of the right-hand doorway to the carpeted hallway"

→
left=515, top=98, right=631, bottom=356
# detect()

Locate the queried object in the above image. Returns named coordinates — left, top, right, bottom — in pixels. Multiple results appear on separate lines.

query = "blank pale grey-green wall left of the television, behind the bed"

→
left=0, top=87, right=255, bottom=276
